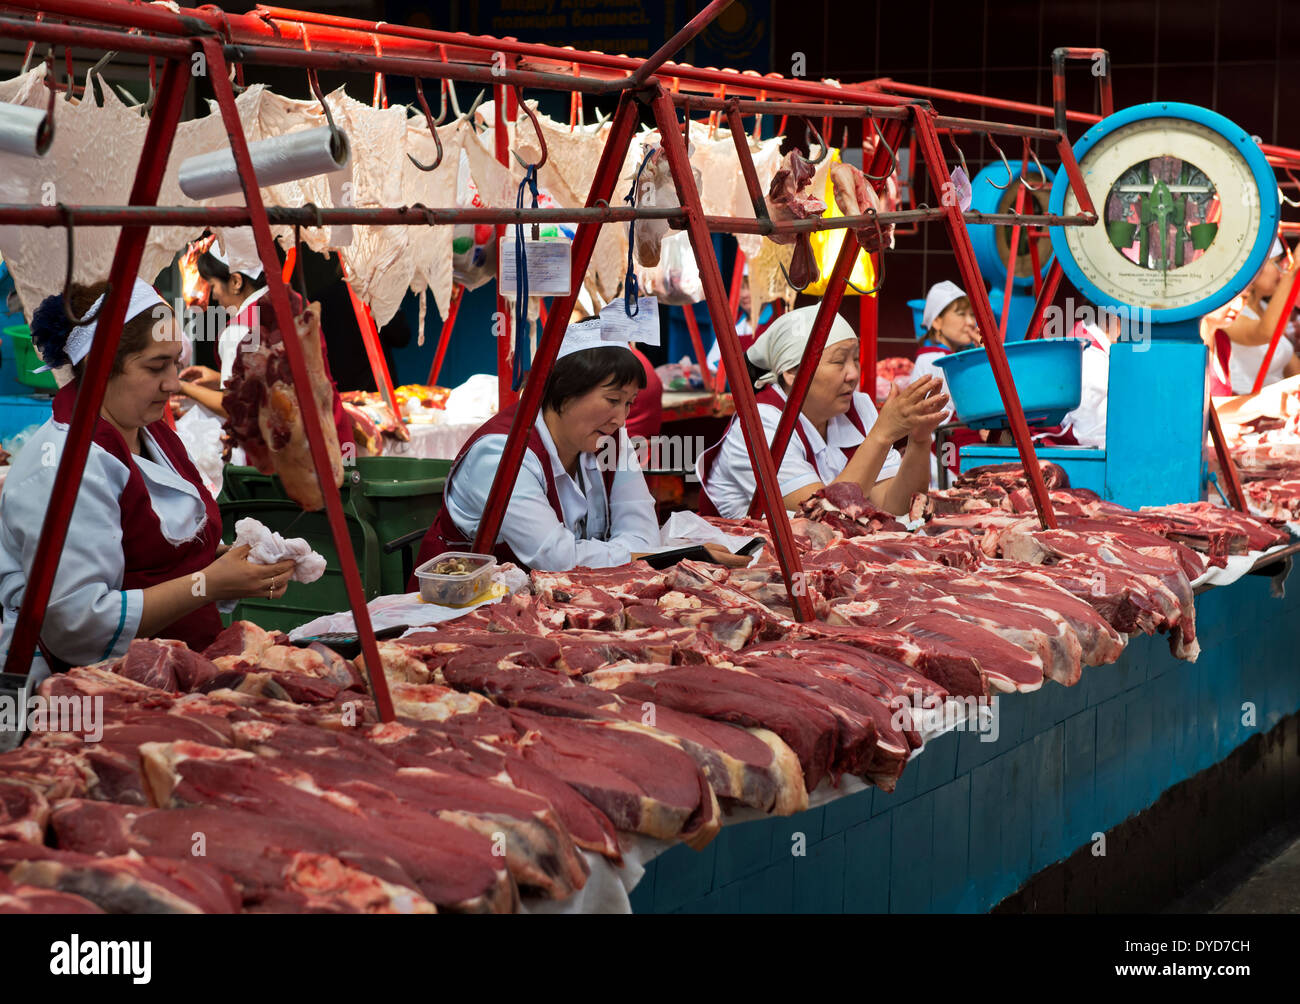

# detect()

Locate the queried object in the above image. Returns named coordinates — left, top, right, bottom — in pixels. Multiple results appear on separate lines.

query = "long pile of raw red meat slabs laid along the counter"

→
left=0, top=468, right=1278, bottom=913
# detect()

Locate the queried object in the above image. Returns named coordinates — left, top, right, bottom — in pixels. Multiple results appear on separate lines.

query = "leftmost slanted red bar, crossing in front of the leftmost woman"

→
left=4, top=60, right=190, bottom=676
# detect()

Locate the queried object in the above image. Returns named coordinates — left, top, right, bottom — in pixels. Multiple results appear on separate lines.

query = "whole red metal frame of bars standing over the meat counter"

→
left=0, top=0, right=1096, bottom=676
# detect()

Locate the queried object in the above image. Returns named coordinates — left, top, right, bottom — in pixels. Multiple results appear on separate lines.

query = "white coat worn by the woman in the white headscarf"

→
left=696, top=386, right=902, bottom=519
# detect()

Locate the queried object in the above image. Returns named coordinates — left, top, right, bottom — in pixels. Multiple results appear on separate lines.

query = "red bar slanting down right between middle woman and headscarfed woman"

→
left=653, top=86, right=815, bottom=620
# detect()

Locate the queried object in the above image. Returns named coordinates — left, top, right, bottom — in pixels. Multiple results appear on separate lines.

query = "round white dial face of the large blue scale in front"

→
left=1061, top=116, right=1265, bottom=311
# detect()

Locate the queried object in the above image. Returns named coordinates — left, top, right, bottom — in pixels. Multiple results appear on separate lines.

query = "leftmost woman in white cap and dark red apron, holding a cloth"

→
left=0, top=280, right=294, bottom=679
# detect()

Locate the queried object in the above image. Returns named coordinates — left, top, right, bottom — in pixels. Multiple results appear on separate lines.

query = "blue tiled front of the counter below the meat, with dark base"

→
left=616, top=546, right=1300, bottom=913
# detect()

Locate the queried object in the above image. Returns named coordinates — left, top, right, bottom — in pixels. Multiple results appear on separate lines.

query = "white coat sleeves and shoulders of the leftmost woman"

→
left=0, top=410, right=207, bottom=678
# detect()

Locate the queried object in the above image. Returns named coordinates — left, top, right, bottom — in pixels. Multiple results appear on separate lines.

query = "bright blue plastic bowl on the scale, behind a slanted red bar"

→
left=935, top=338, right=1088, bottom=429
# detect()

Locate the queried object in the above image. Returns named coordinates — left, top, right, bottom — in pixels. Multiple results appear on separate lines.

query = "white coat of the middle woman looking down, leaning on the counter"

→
left=445, top=416, right=659, bottom=571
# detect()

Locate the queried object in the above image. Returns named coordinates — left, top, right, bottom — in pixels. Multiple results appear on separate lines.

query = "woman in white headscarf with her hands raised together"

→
left=696, top=306, right=948, bottom=519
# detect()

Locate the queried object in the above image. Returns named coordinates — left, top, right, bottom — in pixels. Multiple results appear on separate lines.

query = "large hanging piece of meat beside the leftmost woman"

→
left=221, top=303, right=343, bottom=511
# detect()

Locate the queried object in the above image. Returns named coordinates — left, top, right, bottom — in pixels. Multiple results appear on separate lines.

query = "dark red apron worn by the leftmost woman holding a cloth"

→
left=47, top=384, right=221, bottom=668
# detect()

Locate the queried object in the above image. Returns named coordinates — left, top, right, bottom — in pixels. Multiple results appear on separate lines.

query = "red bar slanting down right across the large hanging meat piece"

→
left=200, top=36, right=395, bottom=722
